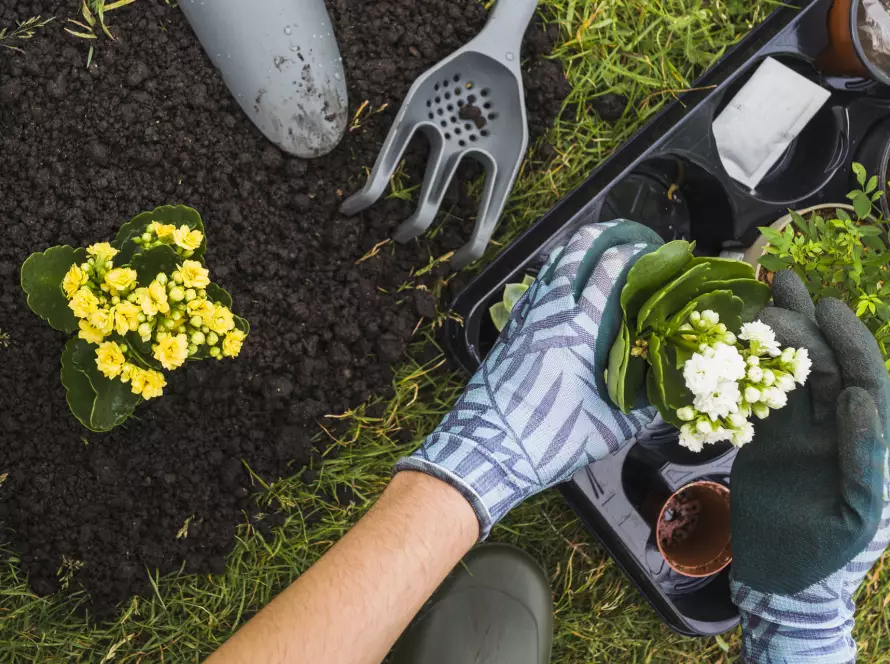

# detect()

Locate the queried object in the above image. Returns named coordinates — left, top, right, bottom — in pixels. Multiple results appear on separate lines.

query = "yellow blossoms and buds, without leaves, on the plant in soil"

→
left=61, top=228, right=247, bottom=399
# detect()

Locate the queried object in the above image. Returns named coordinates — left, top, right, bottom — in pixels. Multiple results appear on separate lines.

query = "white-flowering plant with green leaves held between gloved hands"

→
left=606, top=241, right=811, bottom=452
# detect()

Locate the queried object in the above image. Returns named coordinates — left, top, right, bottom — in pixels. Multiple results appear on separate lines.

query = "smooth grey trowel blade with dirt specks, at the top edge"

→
left=179, top=0, right=348, bottom=158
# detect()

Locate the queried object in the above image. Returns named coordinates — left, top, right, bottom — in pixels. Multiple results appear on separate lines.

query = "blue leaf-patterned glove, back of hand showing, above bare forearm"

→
left=395, top=221, right=662, bottom=539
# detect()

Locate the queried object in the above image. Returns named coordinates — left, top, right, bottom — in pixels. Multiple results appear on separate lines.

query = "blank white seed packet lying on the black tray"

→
left=713, top=58, right=831, bottom=189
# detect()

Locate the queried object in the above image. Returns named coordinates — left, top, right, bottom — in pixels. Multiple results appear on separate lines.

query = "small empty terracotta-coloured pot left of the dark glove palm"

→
left=655, top=481, right=732, bottom=577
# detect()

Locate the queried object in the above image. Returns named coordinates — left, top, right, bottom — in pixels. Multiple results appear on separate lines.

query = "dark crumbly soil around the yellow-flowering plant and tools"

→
left=0, top=0, right=568, bottom=613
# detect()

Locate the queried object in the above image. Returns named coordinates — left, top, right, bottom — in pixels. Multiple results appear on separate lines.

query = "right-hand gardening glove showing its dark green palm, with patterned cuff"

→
left=732, top=271, right=890, bottom=664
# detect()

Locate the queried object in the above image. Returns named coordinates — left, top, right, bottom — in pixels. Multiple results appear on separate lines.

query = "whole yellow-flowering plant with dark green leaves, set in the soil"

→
left=22, top=206, right=250, bottom=431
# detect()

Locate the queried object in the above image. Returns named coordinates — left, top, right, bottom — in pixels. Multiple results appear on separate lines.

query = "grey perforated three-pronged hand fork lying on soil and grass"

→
left=340, top=0, right=538, bottom=268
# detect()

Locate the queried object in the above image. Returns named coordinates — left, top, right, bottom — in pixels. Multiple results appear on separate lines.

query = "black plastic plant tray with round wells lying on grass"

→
left=448, top=0, right=890, bottom=636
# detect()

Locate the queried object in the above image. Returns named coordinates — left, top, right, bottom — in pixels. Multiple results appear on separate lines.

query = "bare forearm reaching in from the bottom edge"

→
left=207, top=472, right=479, bottom=664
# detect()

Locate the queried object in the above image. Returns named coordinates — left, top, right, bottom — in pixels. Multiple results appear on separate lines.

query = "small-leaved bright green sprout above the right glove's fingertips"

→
left=759, top=164, right=890, bottom=369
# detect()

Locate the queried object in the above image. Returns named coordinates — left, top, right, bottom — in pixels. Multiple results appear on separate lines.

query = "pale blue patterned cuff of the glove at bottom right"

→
left=731, top=579, right=856, bottom=664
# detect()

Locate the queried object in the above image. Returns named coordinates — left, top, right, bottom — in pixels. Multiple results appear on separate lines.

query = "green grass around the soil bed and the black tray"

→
left=0, top=0, right=890, bottom=664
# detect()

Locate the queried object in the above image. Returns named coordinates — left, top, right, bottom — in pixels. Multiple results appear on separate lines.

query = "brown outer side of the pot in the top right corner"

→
left=816, top=0, right=890, bottom=85
